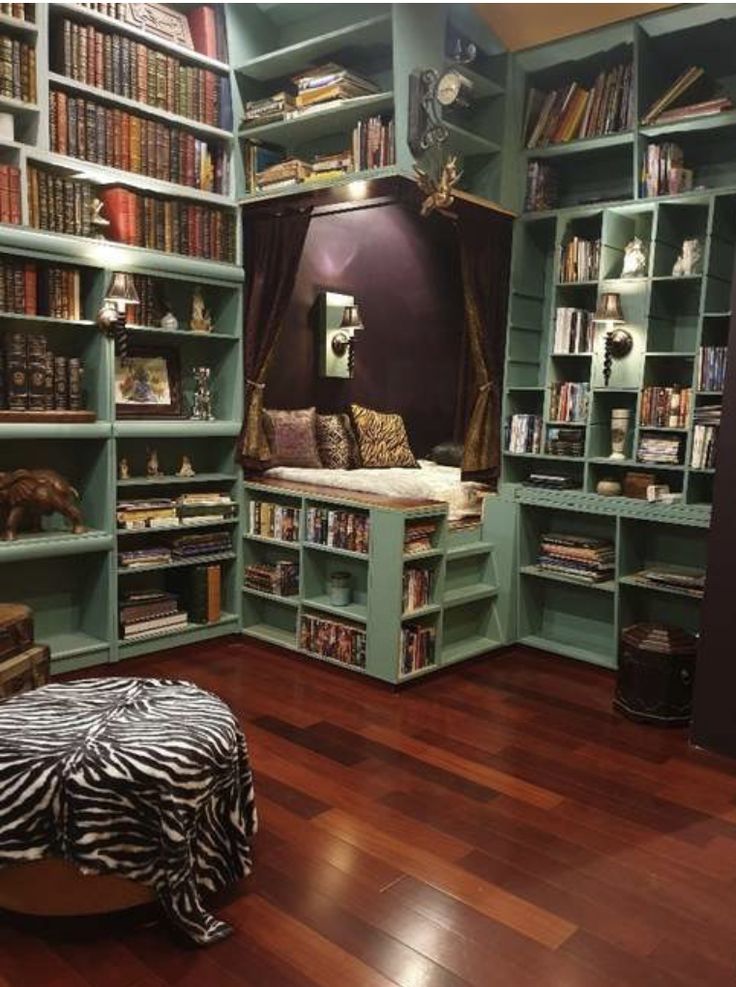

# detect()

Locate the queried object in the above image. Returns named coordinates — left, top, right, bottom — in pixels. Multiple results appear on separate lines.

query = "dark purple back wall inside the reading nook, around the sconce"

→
left=265, top=203, right=463, bottom=456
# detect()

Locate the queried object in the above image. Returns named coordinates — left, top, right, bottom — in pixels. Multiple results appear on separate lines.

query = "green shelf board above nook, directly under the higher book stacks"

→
left=238, top=91, right=394, bottom=147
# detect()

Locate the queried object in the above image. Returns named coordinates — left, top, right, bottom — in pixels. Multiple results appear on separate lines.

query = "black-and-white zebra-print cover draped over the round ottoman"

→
left=0, top=678, right=257, bottom=945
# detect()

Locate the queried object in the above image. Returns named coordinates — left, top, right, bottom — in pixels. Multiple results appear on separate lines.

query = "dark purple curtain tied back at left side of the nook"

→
left=238, top=206, right=312, bottom=469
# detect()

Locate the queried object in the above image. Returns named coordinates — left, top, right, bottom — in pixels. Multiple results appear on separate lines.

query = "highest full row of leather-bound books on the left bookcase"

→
left=56, top=19, right=233, bottom=130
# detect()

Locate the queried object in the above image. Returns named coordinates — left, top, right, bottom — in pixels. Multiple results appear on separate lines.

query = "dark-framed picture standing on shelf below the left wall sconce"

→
left=115, top=346, right=182, bottom=418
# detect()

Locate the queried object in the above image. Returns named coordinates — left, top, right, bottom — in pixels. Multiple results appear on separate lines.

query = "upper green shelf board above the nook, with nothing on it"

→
left=235, top=13, right=391, bottom=81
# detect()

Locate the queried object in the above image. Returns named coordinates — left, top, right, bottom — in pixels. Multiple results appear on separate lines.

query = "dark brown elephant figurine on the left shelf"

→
left=0, top=469, right=84, bottom=541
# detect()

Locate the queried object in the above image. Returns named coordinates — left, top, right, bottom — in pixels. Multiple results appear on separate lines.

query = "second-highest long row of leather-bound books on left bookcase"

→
left=49, top=90, right=230, bottom=194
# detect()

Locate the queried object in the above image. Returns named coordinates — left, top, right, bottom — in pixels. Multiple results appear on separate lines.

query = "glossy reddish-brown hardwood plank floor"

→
left=0, top=639, right=736, bottom=987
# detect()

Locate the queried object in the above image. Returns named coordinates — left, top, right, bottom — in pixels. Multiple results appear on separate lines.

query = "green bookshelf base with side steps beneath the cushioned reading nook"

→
left=242, top=481, right=515, bottom=684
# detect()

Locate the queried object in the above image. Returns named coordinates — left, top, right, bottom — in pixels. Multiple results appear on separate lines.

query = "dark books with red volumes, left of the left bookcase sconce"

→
left=0, top=259, right=82, bottom=319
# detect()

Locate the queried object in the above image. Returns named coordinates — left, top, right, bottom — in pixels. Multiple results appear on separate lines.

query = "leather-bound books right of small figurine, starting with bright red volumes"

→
left=95, top=186, right=235, bottom=262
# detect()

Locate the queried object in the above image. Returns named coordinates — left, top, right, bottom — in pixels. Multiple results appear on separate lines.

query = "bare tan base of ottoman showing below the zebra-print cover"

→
left=0, top=857, right=155, bottom=916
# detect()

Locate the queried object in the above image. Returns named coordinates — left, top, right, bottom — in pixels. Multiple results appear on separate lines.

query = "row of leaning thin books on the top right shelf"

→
left=524, top=62, right=634, bottom=148
